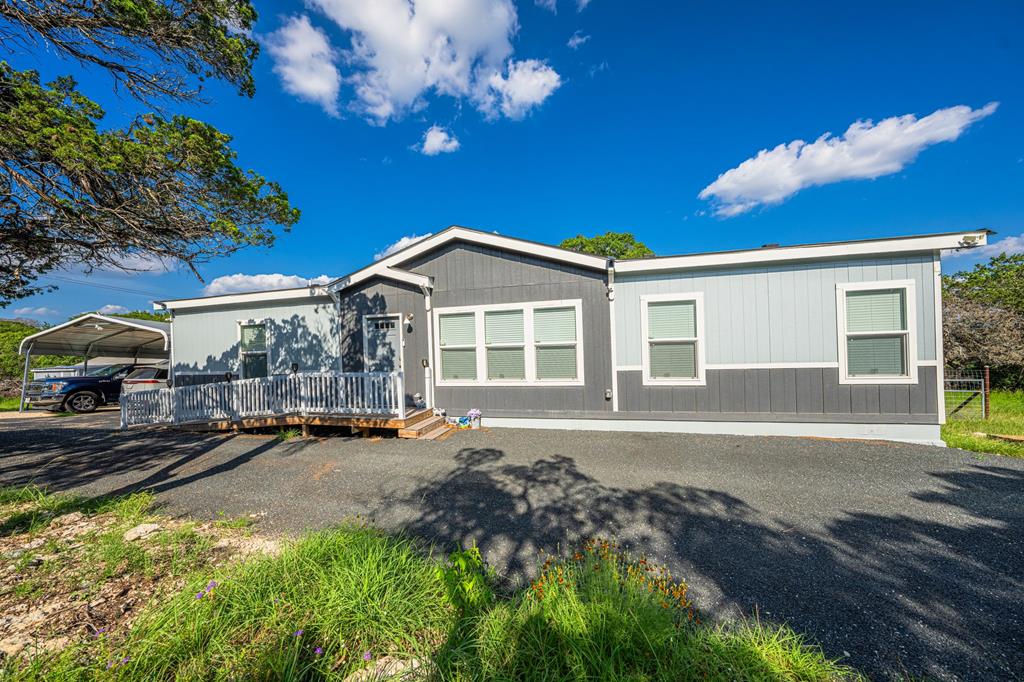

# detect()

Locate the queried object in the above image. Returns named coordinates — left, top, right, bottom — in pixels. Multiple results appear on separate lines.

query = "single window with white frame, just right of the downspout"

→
left=640, top=292, right=706, bottom=386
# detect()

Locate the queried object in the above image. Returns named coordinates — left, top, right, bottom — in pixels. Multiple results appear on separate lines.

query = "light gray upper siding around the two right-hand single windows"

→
left=615, top=254, right=935, bottom=367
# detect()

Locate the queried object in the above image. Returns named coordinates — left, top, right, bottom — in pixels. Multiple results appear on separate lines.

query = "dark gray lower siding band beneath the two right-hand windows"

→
left=615, top=367, right=938, bottom=424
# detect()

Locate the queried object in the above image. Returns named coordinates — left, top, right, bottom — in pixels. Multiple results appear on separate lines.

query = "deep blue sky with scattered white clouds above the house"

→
left=0, top=0, right=1024, bottom=322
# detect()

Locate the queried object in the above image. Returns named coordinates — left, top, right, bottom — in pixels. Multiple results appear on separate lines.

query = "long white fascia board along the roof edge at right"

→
left=615, top=230, right=988, bottom=274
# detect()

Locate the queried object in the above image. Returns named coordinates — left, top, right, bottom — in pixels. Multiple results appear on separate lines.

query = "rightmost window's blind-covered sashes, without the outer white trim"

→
left=845, top=289, right=909, bottom=377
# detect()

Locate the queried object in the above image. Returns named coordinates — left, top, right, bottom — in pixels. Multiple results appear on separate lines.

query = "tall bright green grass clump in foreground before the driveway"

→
left=0, top=525, right=858, bottom=681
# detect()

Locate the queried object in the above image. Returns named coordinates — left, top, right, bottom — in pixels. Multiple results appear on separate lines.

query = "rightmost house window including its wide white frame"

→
left=836, top=280, right=918, bottom=384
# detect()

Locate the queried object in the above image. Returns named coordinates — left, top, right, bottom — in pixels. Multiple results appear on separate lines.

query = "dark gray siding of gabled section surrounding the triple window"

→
left=402, top=243, right=612, bottom=417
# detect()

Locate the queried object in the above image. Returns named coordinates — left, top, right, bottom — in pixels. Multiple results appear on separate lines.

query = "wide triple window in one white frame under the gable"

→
left=434, top=299, right=584, bottom=386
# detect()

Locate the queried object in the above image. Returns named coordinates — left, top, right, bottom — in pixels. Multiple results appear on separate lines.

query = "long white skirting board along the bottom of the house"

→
left=483, top=415, right=945, bottom=447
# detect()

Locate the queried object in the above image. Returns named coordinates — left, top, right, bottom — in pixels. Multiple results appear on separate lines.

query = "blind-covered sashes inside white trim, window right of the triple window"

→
left=646, top=300, right=698, bottom=381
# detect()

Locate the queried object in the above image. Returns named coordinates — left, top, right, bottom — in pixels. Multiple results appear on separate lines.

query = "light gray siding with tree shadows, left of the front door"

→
left=171, top=297, right=339, bottom=385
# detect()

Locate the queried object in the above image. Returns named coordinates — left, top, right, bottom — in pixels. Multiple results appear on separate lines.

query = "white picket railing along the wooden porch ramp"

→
left=121, top=372, right=406, bottom=429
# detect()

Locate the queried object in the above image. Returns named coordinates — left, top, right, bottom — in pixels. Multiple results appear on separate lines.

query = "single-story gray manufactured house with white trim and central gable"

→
left=142, top=226, right=988, bottom=442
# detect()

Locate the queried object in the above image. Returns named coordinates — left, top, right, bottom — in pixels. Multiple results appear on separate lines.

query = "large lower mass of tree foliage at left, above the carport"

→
left=0, top=62, right=299, bottom=305
